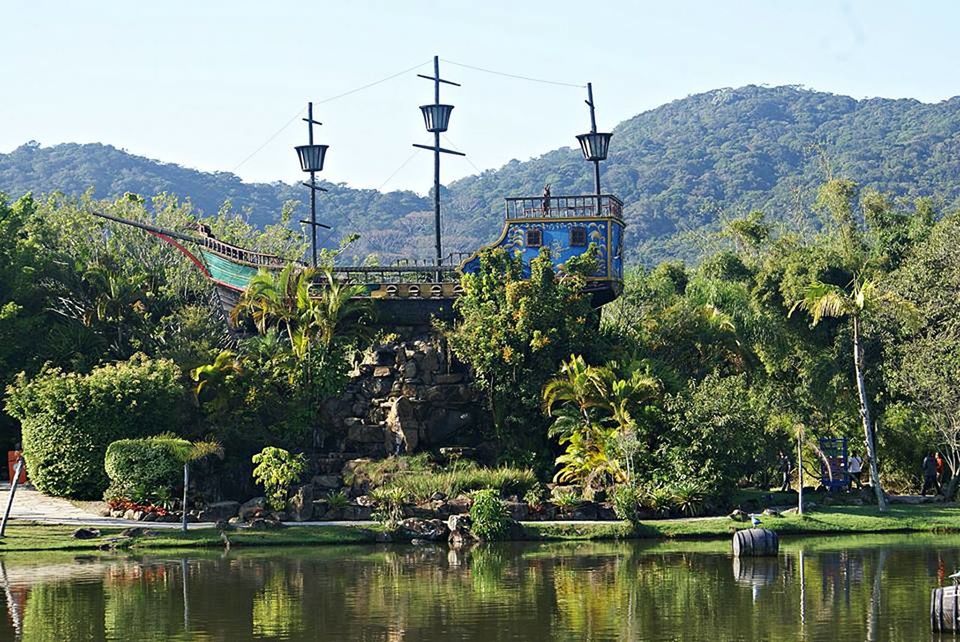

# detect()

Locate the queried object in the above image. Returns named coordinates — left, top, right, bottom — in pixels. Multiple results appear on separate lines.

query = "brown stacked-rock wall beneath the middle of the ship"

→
left=322, top=331, right=484, bottom=457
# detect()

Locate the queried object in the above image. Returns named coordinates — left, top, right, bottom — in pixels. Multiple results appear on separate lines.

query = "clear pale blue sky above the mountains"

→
left=0, top=0, right=960, bottom=192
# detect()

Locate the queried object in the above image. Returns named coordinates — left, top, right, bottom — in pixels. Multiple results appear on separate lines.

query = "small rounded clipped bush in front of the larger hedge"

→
left=104, top=439, right=183, bottom=503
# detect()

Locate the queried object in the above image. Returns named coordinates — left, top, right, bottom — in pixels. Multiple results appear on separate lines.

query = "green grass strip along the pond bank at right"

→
left=524, top=504, right=960, bottom=540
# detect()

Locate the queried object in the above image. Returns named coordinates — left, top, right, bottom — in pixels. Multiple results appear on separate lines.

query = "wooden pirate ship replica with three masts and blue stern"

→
left=97, top=57, right=624, bottom=326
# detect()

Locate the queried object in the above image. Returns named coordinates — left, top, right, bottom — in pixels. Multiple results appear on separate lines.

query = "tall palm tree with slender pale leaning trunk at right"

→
left=790, top=275, right=912, bottom=511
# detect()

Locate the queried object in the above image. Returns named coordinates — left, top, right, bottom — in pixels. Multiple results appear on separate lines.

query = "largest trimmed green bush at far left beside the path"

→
left=6, top=355, right=184, bottom=499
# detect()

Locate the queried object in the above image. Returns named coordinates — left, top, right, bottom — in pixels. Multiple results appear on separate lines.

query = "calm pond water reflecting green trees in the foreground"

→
left=0, top=535, right=960, bottom=642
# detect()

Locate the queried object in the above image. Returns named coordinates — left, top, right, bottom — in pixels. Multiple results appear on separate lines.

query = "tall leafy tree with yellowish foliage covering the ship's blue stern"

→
left=448, top=248, right=597, bottom=464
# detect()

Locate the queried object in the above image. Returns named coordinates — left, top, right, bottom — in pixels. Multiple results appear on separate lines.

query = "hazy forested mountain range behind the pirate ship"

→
left=0, top=86, right=960, bottom=263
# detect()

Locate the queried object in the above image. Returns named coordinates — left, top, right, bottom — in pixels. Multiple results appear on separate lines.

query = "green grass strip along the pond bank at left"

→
left=0, top=523, right=380, bottom=553
